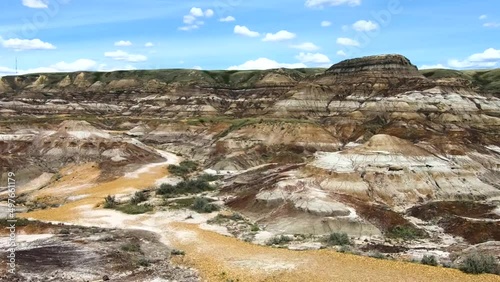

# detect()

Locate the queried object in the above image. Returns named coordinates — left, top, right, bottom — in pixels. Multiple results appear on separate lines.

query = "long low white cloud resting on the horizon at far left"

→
left=0, top=59, right=97, bottom=76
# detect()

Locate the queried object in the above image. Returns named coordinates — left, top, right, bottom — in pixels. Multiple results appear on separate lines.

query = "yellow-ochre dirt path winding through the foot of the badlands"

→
left=16, top=155, right=500, bottom=282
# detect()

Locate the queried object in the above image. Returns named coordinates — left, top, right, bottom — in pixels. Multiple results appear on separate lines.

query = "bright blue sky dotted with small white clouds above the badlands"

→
left=0, top=0, right=500, bottom=76
